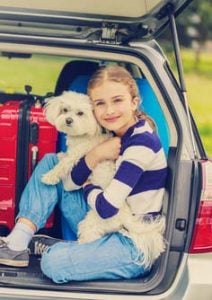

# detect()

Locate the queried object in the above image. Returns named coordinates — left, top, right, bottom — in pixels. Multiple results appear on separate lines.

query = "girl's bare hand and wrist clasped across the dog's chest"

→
left=85, top=137, right=121, bottom=170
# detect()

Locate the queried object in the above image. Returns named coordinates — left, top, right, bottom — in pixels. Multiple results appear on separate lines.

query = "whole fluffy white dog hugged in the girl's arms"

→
left=42, top=91, right=165, bottom=266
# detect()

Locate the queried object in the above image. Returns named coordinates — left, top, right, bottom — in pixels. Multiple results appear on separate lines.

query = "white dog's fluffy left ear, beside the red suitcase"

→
left=44, top=96, right=61, bottom=125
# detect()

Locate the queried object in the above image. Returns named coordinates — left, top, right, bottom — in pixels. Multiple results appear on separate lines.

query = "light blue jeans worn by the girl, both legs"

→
left=17, top=154, right=146, bottom=283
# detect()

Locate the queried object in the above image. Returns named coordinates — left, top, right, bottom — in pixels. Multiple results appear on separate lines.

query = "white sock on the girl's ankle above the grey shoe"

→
left=5, top=222, right=34, bottom=251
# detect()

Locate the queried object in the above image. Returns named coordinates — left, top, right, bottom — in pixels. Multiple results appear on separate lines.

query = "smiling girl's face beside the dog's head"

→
left=90, top=81, right=138, bottom=137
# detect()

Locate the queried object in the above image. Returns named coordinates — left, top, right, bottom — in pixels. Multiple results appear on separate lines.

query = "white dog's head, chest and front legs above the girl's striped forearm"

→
left=42, top=91, right=115, bottom=191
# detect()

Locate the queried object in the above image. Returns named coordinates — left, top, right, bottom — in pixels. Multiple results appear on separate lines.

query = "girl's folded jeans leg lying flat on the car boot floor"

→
left=41, top=233, right=146, bottom=283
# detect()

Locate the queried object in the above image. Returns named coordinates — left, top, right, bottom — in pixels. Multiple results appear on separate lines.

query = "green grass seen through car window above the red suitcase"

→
left=0, top=55, right=70, bottom=95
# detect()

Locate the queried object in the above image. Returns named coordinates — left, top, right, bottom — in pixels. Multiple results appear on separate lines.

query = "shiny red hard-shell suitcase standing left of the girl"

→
left=0, top=99, right=57, bottom=235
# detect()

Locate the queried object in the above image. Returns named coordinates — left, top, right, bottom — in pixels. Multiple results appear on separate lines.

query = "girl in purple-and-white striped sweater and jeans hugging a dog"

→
left=0, top=66, right=167, bottom=283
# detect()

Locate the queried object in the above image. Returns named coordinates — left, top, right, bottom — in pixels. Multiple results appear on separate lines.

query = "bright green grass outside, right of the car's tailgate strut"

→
left=169, top=49, right=212, bottom=157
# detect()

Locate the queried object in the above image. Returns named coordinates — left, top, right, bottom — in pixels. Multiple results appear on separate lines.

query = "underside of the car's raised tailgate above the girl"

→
left=0, top=0, right=191, bottom=43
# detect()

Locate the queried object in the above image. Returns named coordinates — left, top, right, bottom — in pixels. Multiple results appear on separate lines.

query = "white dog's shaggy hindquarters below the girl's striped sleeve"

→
left=78, top=204, right=166, bottom=267
